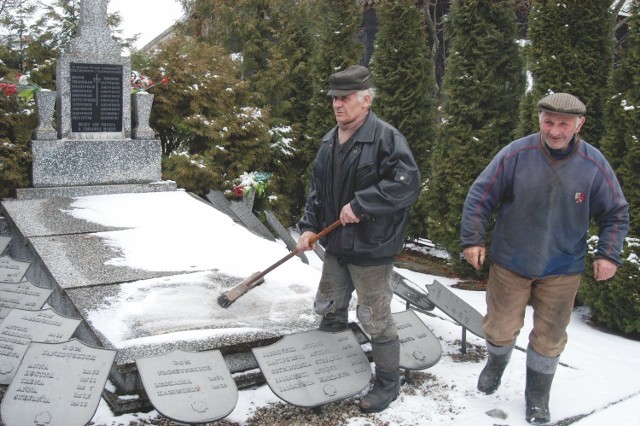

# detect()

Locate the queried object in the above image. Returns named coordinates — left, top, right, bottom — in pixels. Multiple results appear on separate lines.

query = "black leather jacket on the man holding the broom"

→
left=298, top=111, right=420, bottom=265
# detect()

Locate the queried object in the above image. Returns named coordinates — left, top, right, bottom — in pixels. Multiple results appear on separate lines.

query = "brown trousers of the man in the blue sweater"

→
left=482, top=263, right=581, bottom=357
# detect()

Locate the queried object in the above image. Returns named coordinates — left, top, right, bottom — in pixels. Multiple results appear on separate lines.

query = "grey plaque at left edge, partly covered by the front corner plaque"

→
left=0, top=309, right=81, bottom=385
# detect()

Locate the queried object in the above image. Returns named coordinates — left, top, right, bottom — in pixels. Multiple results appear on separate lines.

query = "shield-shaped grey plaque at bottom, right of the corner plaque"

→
left=136, top=350, right=238, bottom=424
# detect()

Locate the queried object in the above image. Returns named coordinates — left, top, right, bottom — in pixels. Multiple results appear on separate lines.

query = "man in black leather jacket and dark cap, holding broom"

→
left=298, top=65, right=420, bottom=412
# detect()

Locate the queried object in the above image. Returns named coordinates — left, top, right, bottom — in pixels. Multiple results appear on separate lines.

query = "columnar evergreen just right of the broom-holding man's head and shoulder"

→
left=371, top=0, right=436, bottom=237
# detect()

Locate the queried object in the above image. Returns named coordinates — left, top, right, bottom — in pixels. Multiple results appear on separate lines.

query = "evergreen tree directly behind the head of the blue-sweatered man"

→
left=527, top=0, right=614, bottom=147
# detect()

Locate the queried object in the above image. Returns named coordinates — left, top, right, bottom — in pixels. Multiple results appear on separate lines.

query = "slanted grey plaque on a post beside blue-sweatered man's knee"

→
left=426, top=280, right=484, bottom=338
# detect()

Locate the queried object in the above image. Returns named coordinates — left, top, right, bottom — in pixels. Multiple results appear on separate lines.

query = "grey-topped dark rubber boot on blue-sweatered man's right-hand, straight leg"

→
left=524, top=347, right=560, bottom=425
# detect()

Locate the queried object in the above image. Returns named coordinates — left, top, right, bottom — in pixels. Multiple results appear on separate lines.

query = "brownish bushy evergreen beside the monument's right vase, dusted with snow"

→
left=132, top=35, right=270, bottom=195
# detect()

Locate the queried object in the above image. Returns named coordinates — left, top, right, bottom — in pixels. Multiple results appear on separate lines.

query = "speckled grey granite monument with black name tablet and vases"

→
left=17, top=0, right=175, bottom=199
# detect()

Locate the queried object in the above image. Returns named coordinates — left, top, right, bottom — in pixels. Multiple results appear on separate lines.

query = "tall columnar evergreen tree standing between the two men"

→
left=427, top=0, right=524, bottom=272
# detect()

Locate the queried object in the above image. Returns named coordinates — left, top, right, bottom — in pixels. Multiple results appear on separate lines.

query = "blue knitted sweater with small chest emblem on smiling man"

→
left=461, top=133, right=629, bottom=278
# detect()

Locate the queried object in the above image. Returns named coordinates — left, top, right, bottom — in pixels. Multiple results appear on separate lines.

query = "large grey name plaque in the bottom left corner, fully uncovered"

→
left=1, top=339, right=116, bottom=426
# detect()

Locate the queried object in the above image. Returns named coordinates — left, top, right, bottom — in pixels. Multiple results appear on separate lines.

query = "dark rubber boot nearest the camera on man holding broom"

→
left=360, top=337, right=400, bottom=413
